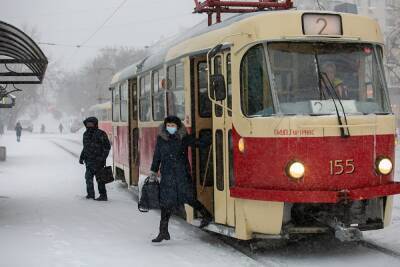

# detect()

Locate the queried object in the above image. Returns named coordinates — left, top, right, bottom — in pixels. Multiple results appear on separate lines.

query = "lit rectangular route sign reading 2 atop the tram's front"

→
left=302, top=13, right=343, bottom=35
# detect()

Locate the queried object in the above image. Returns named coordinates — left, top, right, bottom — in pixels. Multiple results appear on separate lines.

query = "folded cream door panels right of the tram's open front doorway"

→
left=210, top=50, right=235, bottom=226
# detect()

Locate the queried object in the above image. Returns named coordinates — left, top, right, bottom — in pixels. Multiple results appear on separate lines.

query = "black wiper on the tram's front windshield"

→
left=314, top=53, right=350, bottom=138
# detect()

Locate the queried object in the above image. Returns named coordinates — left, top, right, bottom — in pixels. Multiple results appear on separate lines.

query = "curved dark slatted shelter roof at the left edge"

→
left=0, top=21, right=48, bottom=84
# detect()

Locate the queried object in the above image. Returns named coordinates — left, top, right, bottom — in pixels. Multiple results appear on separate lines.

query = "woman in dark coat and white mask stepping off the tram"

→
left=150, top=116, right=212, bottom=242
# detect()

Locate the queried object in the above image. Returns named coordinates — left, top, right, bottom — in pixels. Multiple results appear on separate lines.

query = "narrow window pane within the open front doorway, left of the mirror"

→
left=197, top=61, right=212, bottom=118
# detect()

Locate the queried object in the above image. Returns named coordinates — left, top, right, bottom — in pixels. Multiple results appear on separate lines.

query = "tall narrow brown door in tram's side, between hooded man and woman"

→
left=129, top=78, right=139, bottom=186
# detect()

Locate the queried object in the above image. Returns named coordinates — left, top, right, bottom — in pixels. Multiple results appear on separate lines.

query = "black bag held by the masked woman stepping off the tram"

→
left=138, top=177, right=160, bottom=212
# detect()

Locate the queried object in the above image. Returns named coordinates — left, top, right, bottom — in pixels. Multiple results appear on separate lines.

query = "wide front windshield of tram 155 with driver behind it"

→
left=241, top=42, right=390, bottom=116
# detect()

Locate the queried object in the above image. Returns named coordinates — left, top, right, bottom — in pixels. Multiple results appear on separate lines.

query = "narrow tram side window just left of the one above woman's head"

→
left=153, top=69, right=165, bottom=121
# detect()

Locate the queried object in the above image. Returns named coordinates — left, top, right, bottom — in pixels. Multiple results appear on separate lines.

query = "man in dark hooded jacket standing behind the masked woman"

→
left=79, top=117, right=111, bottom=201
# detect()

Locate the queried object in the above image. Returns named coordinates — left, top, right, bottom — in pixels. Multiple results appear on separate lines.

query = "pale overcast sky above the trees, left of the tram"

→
left=0, top=0, right=206, bottom=69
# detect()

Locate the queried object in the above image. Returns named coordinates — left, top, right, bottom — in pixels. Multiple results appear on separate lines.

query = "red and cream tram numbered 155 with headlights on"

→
left=110, top=5, right=400, bottom=240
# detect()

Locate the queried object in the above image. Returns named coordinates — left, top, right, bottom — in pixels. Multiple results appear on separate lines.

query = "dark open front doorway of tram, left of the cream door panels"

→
left=191, top=56, right=214, bottom=216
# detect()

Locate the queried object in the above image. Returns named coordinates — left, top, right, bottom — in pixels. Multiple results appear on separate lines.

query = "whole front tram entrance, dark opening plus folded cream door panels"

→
left=191, top=47, right=235, bottom=226
